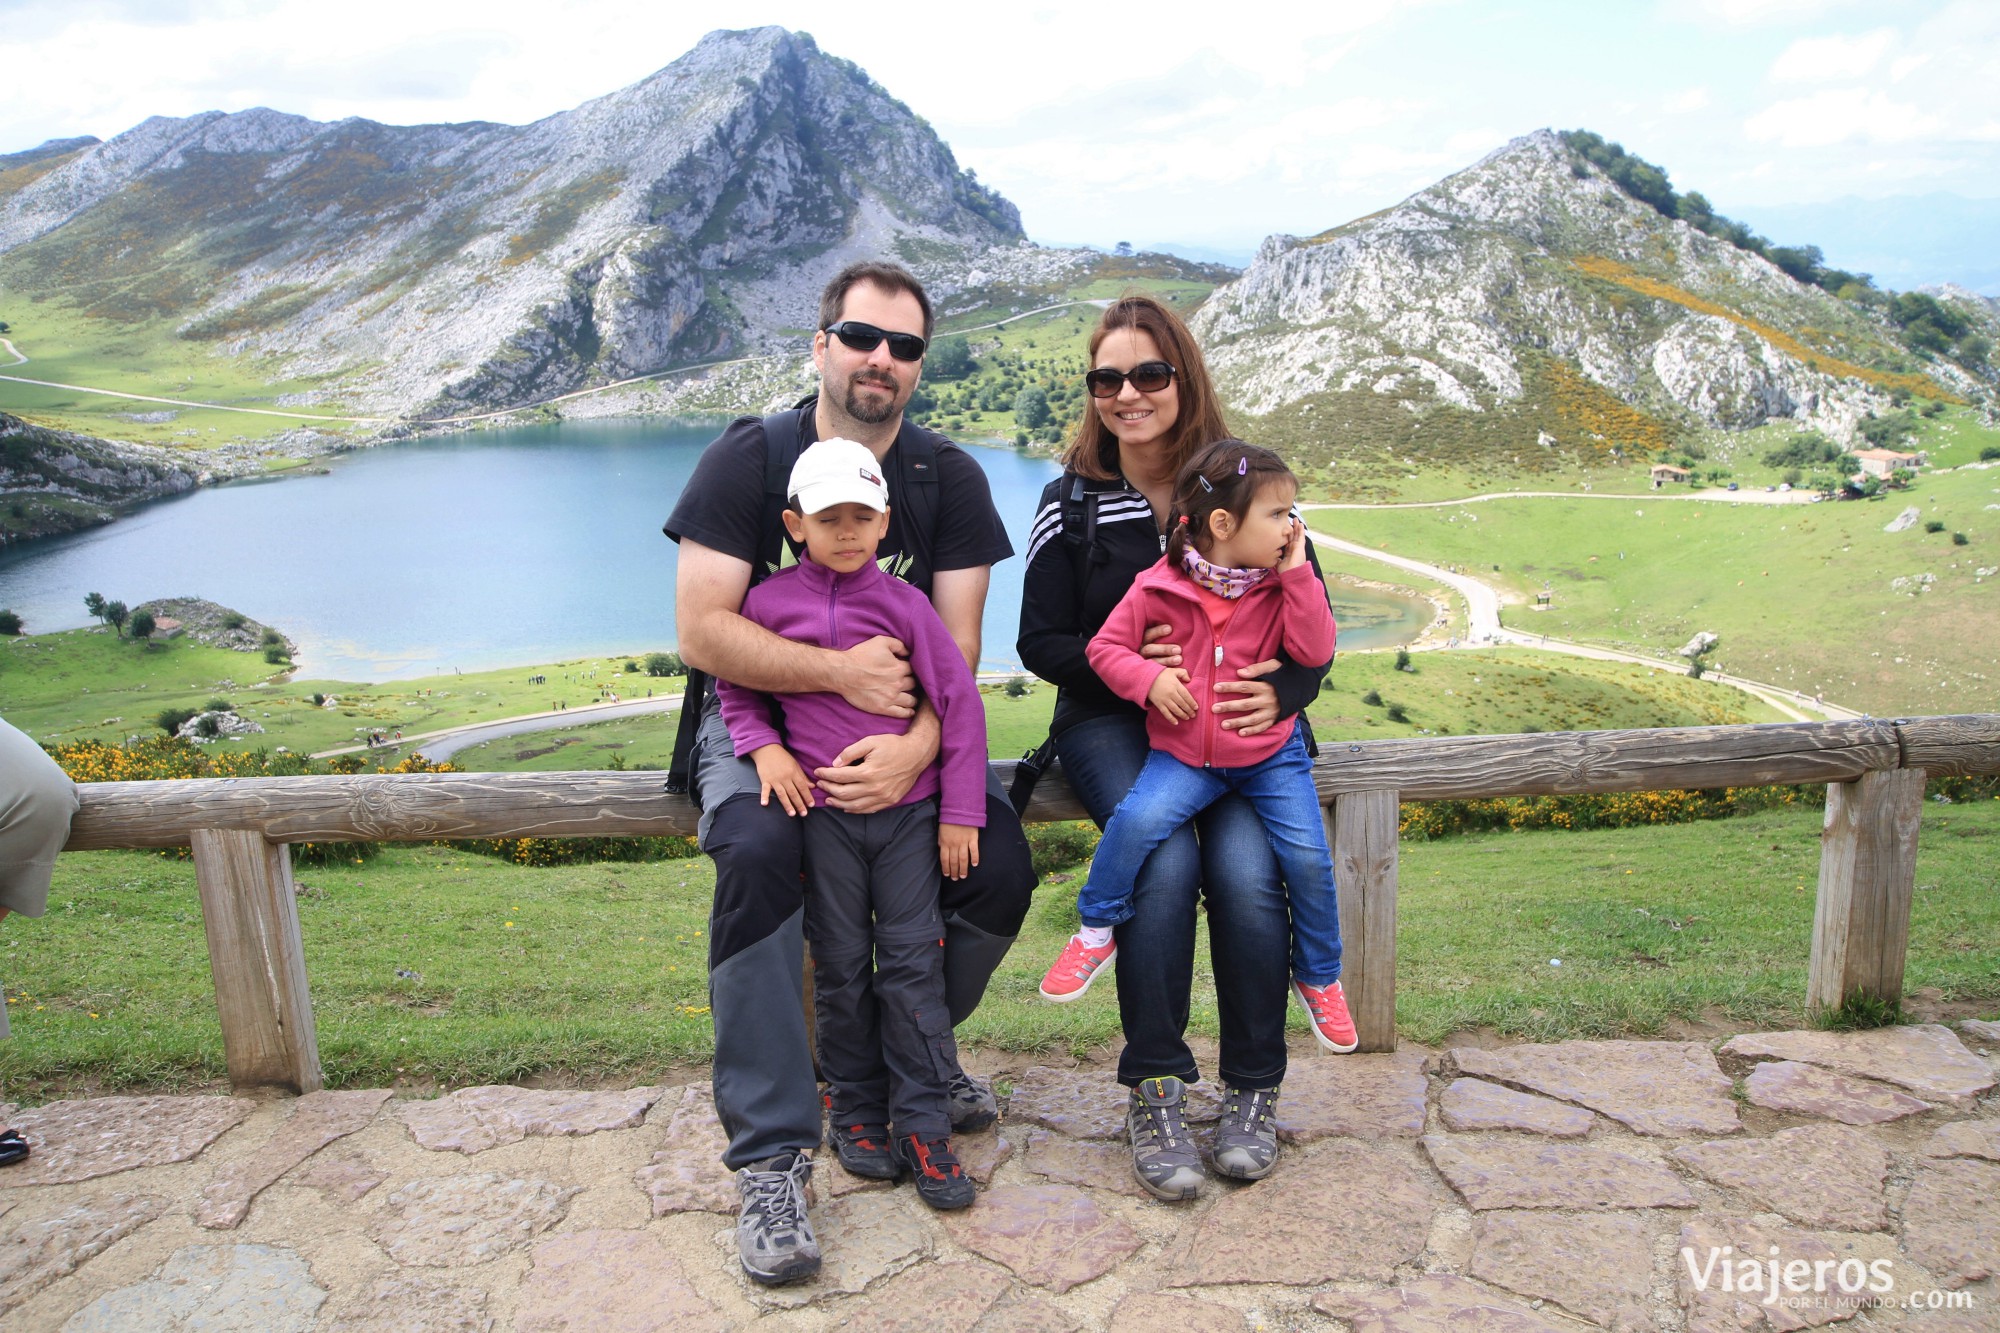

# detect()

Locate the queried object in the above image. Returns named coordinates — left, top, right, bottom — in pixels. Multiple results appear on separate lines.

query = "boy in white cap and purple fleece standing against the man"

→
left=716, top=440, right=986, bottom=1209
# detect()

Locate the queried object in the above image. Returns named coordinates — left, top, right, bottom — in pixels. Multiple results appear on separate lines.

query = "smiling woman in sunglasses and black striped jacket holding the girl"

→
left=1016, top=296, right=1326, bottom=1199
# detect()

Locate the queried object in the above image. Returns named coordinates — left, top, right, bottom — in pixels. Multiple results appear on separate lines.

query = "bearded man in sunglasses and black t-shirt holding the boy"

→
left=666, top=262, right=1034, bottom=1283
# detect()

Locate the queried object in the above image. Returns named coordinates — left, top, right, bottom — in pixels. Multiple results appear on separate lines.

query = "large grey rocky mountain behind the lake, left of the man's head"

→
left=0, top=28, right=1026, bottom=416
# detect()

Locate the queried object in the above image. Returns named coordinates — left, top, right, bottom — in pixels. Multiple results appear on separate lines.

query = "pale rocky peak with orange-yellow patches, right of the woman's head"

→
left=1196, top=130, right=1992, bottom=466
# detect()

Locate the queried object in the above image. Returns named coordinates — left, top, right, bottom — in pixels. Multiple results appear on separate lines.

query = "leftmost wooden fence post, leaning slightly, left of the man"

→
left=188, top=829, right=324, bottom=1093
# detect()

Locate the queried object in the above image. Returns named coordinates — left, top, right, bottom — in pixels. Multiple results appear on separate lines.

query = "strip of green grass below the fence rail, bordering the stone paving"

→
left=0, top=801, right=2000, bottom=1103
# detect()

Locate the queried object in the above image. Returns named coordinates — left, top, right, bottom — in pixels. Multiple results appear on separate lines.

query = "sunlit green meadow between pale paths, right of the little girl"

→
left=1312, top=468, right=2000, bottom=715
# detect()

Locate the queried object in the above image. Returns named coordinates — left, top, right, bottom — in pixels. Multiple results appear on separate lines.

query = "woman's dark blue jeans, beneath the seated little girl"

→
left=1056, top=713, right=1292, bottom=1087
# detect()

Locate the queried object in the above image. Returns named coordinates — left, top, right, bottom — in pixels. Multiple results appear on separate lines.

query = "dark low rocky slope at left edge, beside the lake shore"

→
left=0, top=412, right=200, bottom=546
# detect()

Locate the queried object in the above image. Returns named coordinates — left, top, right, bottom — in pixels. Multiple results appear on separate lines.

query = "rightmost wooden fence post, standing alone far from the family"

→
left=1806, top=769, right=1924, bottom=1011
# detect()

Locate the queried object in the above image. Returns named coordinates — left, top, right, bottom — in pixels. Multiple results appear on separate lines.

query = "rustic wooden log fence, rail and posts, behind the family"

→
left=54, top=713, right=2000, bottom=1093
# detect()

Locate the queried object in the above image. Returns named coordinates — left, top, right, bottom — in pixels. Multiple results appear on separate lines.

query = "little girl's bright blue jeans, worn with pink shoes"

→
left=1076, top=727, right=1340, bottom=987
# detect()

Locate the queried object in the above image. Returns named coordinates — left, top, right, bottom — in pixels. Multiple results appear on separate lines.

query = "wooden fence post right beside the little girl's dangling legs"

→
left=1326, top=791, right=1398, bottom=1051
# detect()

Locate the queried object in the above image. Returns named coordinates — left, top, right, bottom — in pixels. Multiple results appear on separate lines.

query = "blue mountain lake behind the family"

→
left=0, top=420, right=1432, bottom=681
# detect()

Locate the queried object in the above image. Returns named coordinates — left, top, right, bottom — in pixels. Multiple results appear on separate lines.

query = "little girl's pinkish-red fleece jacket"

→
left=1086, top=556, right=1336, bottom=769
